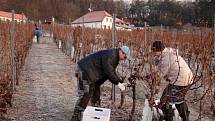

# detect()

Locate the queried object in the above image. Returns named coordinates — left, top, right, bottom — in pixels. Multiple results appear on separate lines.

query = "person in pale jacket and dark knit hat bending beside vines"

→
left=151, top=41, right=193, bottom=121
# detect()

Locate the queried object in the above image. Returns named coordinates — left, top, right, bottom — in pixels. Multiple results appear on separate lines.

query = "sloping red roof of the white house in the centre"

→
left=72, top=11, right=112, bottom=24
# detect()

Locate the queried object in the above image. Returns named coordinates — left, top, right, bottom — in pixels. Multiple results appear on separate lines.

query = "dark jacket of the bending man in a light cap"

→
left=78, top=49, right=122, bottom=84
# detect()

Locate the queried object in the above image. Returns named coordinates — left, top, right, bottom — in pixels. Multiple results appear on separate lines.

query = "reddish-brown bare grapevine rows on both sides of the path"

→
left=0, top=22, right=215, bottom=121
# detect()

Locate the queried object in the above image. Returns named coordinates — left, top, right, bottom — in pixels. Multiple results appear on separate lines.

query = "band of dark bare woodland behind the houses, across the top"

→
left=0, top=0, right=215, bottom=27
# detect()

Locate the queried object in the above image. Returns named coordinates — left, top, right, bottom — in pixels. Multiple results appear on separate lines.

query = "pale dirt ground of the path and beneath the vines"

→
left=3, top=37, right=215, bottom=121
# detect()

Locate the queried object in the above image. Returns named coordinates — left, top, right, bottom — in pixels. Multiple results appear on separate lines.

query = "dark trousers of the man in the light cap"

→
left=71, top=75, right=104, bottom=121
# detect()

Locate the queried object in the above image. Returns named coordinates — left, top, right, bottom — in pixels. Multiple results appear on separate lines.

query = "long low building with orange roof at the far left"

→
left=0, top=11, right=27, bottom=23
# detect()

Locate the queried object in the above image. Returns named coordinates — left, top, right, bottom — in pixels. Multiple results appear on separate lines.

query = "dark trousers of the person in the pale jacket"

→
left=161, top=84, right=190, bottom=121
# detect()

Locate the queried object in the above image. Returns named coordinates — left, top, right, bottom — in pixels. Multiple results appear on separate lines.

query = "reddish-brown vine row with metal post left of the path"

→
left=0, top=11, right=34, bottom=116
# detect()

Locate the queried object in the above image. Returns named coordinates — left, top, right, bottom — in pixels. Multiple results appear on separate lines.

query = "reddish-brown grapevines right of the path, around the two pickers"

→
left=53, top=25, right=215, bottom=120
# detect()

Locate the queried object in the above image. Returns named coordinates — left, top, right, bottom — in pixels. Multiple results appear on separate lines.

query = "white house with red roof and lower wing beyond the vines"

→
left=72, top=11, right=131, bottom=30
